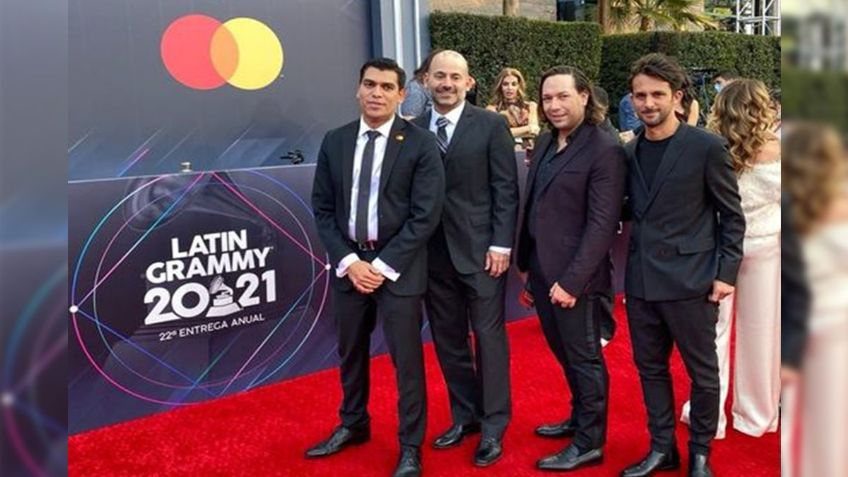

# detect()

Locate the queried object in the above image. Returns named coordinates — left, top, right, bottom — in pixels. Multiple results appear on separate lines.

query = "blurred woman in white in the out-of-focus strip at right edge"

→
left=781, top=124, right=848, bottom=477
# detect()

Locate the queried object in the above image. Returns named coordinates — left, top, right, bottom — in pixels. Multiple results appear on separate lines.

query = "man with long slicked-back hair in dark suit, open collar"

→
left=518, top=66, right=625, bottom=471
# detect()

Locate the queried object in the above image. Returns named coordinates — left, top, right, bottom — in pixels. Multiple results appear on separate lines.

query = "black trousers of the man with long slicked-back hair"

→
left=529, top=250, right=609, bottom=451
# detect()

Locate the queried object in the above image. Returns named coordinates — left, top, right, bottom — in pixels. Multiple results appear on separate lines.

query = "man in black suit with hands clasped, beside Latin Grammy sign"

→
left=306, top=58, right=445, bottom=477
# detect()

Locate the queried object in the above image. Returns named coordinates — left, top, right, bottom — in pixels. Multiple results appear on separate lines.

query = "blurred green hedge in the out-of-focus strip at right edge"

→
left=781, top=69, right=848, bottom=132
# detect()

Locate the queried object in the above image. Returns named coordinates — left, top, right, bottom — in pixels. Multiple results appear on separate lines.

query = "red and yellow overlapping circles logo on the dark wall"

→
left=160, top=15, right=283, bottom=90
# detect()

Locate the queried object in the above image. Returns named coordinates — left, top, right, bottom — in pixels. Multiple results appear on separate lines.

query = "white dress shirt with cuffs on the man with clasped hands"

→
left=336, top=116, right=400, bottom=282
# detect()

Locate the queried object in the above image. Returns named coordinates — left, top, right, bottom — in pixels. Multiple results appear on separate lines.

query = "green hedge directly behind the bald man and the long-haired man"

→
left=430, top=12, right=601, bottom=104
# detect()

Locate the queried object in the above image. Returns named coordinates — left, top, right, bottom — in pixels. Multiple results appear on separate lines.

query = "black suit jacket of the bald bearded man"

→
left=413, top=102, right=518, bottom=274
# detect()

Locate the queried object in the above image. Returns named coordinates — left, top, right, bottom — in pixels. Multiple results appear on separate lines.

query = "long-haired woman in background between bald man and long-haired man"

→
left=486, top=68, right=539, bottom=149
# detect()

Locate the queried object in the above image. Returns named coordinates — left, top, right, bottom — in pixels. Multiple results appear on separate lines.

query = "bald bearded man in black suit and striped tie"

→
left=415, top=51, right=518, bottom=466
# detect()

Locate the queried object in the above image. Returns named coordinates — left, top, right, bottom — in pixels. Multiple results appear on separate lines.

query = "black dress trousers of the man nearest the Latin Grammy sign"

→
left=333, top=257, right=427, bottom=447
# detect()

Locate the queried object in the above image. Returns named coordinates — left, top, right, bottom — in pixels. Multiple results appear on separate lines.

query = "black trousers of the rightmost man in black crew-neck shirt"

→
left=627, top=296, right=719, bottom=454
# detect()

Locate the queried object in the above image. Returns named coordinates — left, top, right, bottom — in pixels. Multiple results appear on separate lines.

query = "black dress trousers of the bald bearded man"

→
left=426, top=228, right=511, bottom=438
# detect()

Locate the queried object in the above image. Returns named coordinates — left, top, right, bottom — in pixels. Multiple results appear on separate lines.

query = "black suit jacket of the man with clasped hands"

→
left=312, top=116, right=445, bottom=296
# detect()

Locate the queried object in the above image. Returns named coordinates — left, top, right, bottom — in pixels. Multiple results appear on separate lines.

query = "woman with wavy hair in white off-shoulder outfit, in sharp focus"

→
left=682, top=79, right=780, bottom=439
